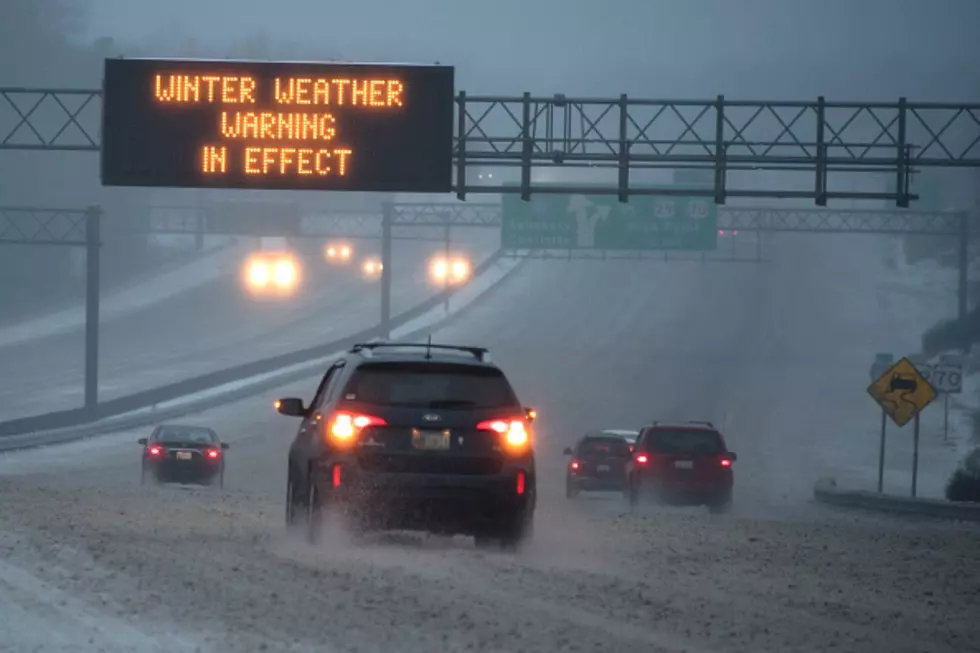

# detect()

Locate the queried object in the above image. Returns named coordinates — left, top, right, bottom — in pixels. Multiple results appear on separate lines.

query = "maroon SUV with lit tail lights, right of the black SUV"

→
left=626, top=422, right=736, bottom=512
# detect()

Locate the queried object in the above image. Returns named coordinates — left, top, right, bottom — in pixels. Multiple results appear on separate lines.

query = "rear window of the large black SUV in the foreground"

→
left=343, top=363, right=518, bottom=408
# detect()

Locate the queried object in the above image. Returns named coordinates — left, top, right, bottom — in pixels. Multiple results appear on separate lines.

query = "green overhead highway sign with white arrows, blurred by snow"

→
left=501, top=188, right=718, bottom=251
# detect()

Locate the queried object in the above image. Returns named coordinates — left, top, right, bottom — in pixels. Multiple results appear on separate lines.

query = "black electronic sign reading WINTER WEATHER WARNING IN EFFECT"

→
left=102, top=59, right=455, bottom=193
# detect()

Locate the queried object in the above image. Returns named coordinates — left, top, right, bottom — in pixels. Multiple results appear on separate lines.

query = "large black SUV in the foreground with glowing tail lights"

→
left=276, top=342, right=536, bottom=547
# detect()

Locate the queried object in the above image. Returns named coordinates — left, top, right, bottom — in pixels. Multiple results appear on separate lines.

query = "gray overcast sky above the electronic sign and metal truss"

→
left=88, top=0, right=980, bottom=99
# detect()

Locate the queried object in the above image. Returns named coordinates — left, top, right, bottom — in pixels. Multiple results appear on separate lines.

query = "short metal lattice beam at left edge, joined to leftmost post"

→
left=0, top=206, right=88, bottom=247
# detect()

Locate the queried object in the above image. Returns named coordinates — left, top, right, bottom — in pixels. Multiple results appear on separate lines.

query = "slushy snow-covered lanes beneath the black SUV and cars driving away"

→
left=0, top=232, right=980, bottom=653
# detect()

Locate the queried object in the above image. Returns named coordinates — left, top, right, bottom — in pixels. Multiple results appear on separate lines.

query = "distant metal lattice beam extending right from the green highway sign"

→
left=718, top=207, right=966, bottom=236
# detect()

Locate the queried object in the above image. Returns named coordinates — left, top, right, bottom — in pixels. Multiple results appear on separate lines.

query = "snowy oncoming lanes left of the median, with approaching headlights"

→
left=0, top=229, right=499, bottom=420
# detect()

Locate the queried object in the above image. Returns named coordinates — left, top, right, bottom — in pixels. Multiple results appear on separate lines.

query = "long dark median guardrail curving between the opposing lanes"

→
left=0, top=250, right=504, bottom=437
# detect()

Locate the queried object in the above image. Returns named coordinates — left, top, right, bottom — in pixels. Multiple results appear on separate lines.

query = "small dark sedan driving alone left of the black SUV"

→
left=138, top=424, right=228, bottom=487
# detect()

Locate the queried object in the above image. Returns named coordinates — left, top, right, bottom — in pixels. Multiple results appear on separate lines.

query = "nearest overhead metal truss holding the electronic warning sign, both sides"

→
left=0, top=88, right=980, bottom=202
